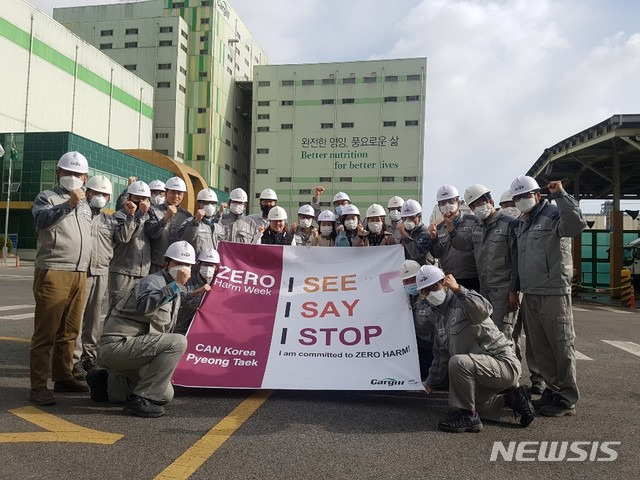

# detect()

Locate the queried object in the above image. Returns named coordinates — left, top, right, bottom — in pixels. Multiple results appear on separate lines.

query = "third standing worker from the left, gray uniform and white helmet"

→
left=109, top=180, right=151, bottom=312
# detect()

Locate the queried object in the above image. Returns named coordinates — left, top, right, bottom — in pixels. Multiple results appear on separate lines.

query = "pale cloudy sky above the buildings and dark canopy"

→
left=29, top=0, right=640, bottom=212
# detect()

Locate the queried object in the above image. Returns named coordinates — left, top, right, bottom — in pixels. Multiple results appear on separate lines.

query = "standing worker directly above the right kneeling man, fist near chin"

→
left=429, top=185, right=480, bottom=292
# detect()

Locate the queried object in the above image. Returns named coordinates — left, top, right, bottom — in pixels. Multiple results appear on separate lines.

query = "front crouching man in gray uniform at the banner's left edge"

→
left=87, top=241, right=196, bottom=417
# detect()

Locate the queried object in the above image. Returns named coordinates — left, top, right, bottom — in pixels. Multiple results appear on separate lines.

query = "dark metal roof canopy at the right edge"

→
left=527, top=114, right=640, bottom=201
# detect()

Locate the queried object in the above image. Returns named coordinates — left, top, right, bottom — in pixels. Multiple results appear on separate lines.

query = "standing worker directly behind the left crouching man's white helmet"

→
left=145, top=177, right=192, bottom=273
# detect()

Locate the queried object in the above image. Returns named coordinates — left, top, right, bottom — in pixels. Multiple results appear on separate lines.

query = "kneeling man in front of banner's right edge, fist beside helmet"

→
left=417, top=265, right=535, bottom=433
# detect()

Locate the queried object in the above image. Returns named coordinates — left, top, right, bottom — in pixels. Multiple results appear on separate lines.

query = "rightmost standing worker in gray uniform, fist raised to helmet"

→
left=511, top=175, right=586, bottom=417
